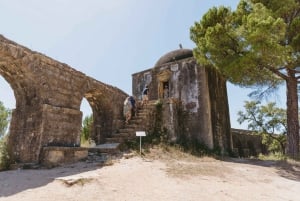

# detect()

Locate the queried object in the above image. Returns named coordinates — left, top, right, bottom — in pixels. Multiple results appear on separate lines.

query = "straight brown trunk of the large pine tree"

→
left=286, top=70, right=299, bottom=158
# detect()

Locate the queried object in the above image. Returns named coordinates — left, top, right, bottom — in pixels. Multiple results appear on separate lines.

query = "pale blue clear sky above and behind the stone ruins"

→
left=0, top=0, right=285, bottom=128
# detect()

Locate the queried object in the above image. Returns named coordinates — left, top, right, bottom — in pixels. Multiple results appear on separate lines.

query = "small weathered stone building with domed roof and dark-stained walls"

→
left=132, top=49, right=232, bottom=152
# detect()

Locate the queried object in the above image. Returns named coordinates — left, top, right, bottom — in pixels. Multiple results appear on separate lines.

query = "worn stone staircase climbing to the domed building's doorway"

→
left=89, top=100, right=156, bottom=160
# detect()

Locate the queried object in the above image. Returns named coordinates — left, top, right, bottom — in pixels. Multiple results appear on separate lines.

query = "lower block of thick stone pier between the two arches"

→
left=9, top=104, right=82, bottom=163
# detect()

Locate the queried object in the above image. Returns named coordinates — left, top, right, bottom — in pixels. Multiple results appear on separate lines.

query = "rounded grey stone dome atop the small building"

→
left=155, top=49, right=193, bottom=66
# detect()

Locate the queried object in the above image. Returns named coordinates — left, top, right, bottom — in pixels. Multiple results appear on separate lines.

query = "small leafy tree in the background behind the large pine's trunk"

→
left=238, top=101, right=287, bottom=154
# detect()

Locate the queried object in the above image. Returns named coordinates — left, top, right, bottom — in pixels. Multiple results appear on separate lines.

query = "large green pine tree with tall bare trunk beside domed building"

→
left=190, top=0, right=300, bottom=157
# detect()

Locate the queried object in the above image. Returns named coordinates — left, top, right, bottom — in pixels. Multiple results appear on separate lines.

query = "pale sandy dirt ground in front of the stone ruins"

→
left=0, top=149, right=300, bottom=201
